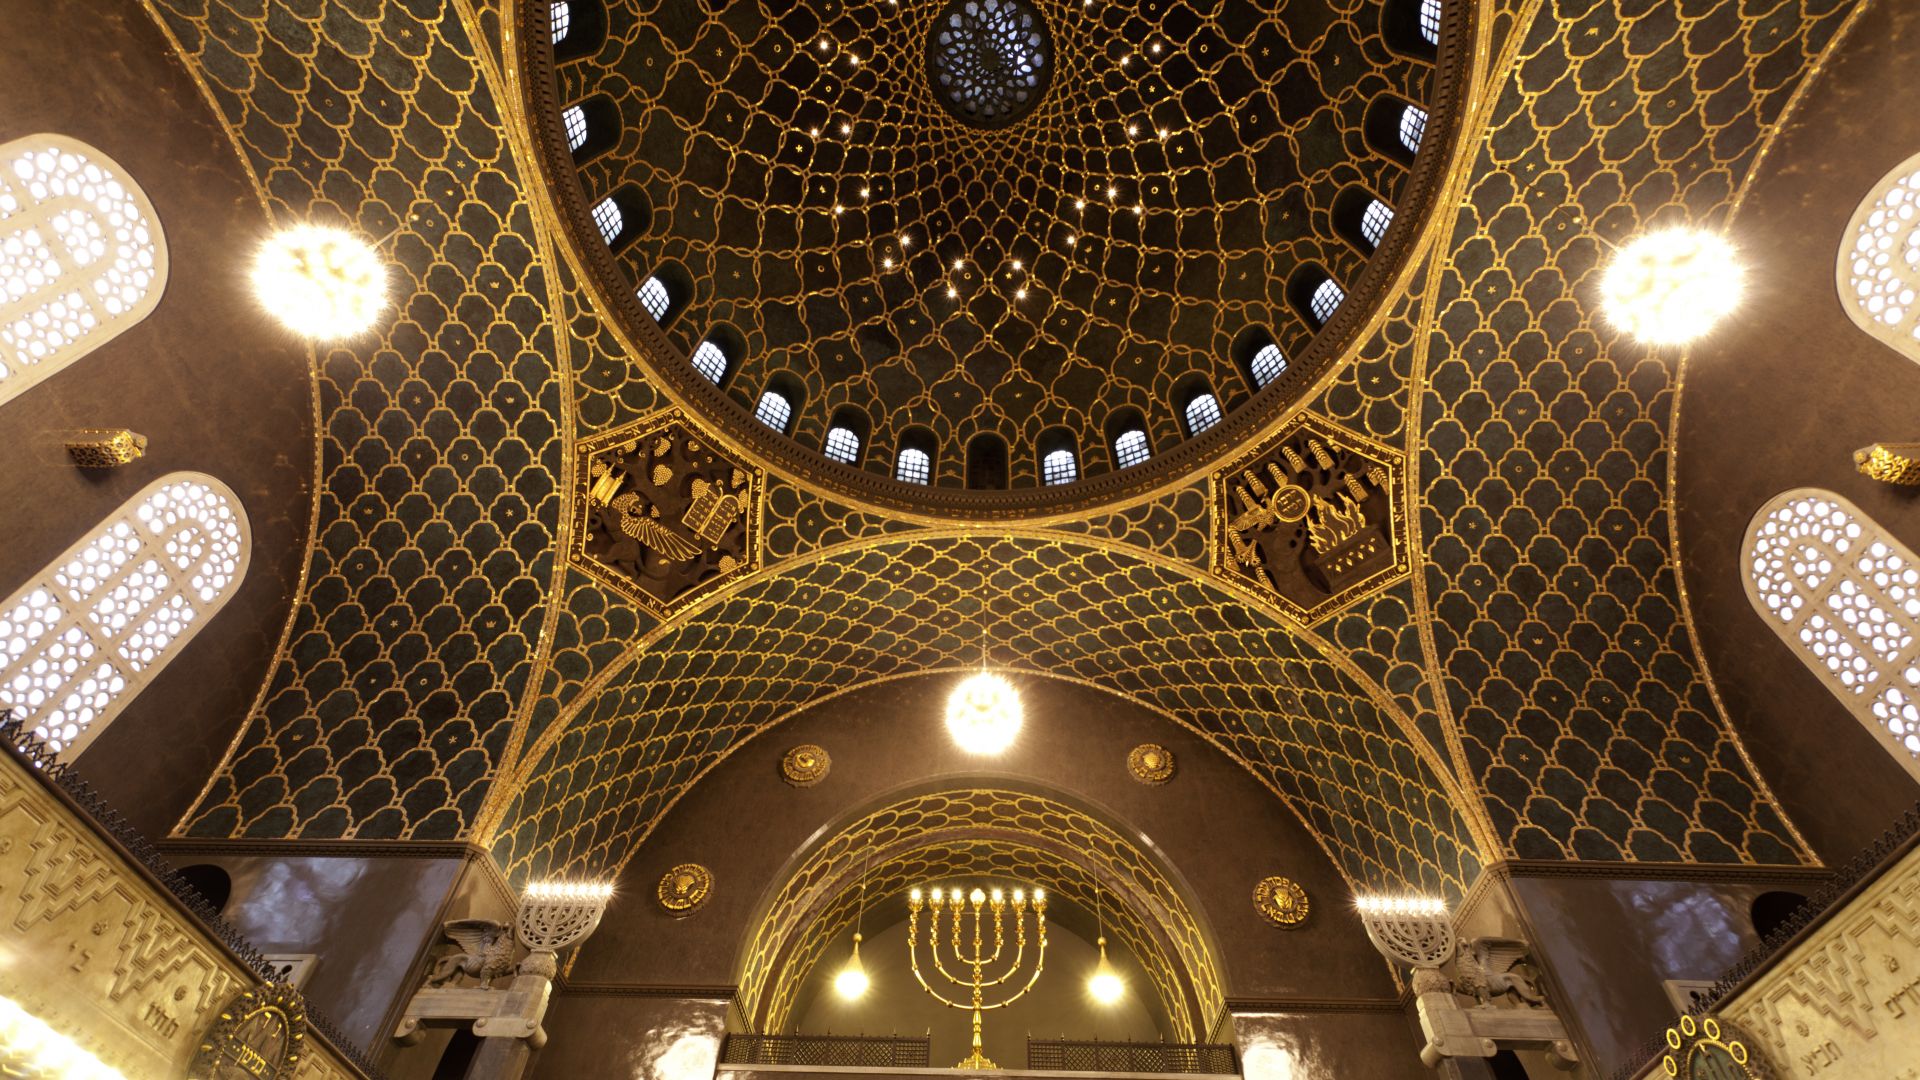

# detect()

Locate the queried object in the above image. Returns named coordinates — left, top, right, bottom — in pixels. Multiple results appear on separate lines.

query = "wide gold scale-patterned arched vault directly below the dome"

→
left=492, top=536, right=1480, bottom=892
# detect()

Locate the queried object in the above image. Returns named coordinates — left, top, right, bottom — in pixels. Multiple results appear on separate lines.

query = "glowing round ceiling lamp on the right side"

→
left=1599, top=229, right=1745, bottom=346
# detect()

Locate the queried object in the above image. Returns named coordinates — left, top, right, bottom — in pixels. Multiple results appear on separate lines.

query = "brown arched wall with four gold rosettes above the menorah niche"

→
left=568, top=675, right=1396, bottom=999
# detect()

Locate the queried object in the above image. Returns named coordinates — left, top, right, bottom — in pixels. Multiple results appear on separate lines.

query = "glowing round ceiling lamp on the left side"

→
left=253, top=225, right=388, bottom=340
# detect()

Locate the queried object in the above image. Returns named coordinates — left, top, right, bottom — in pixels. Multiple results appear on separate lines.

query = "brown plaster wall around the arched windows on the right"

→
left=1676, top=0, right=1920, bottom=863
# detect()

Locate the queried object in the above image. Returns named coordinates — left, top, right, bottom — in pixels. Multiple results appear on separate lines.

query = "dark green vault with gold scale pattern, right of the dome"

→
left=1417, top=0, right=1851, bottom=863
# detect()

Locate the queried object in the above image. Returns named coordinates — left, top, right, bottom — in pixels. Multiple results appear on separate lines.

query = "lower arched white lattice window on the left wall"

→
left=0, top=473, right=252, bottom=757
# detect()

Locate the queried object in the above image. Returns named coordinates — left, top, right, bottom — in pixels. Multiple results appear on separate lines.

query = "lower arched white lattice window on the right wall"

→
left=1745, top=488, right=1920, bottom=778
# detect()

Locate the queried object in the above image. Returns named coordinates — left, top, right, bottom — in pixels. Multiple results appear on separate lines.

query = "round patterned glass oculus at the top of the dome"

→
left=927, top=0, right=1052, bottom=127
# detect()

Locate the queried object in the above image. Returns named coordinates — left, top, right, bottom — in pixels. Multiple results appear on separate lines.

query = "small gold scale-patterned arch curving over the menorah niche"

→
left=739, top=788, right=1225, bottom=1038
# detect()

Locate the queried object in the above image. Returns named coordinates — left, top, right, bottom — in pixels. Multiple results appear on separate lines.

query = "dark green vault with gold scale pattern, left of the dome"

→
left=150, top=0, right=578, bottom=838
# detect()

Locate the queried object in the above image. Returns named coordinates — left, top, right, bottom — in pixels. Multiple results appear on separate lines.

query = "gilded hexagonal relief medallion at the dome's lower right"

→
left=1208, top=411, right=1413, bottom=625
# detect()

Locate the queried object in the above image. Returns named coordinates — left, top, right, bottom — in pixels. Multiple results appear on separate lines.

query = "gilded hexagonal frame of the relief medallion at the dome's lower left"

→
left=566, top=407, right=766, bottom=619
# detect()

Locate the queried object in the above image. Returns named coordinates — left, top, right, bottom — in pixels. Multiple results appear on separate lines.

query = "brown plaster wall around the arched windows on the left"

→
left=0, top=0, right=315, bottom=836
